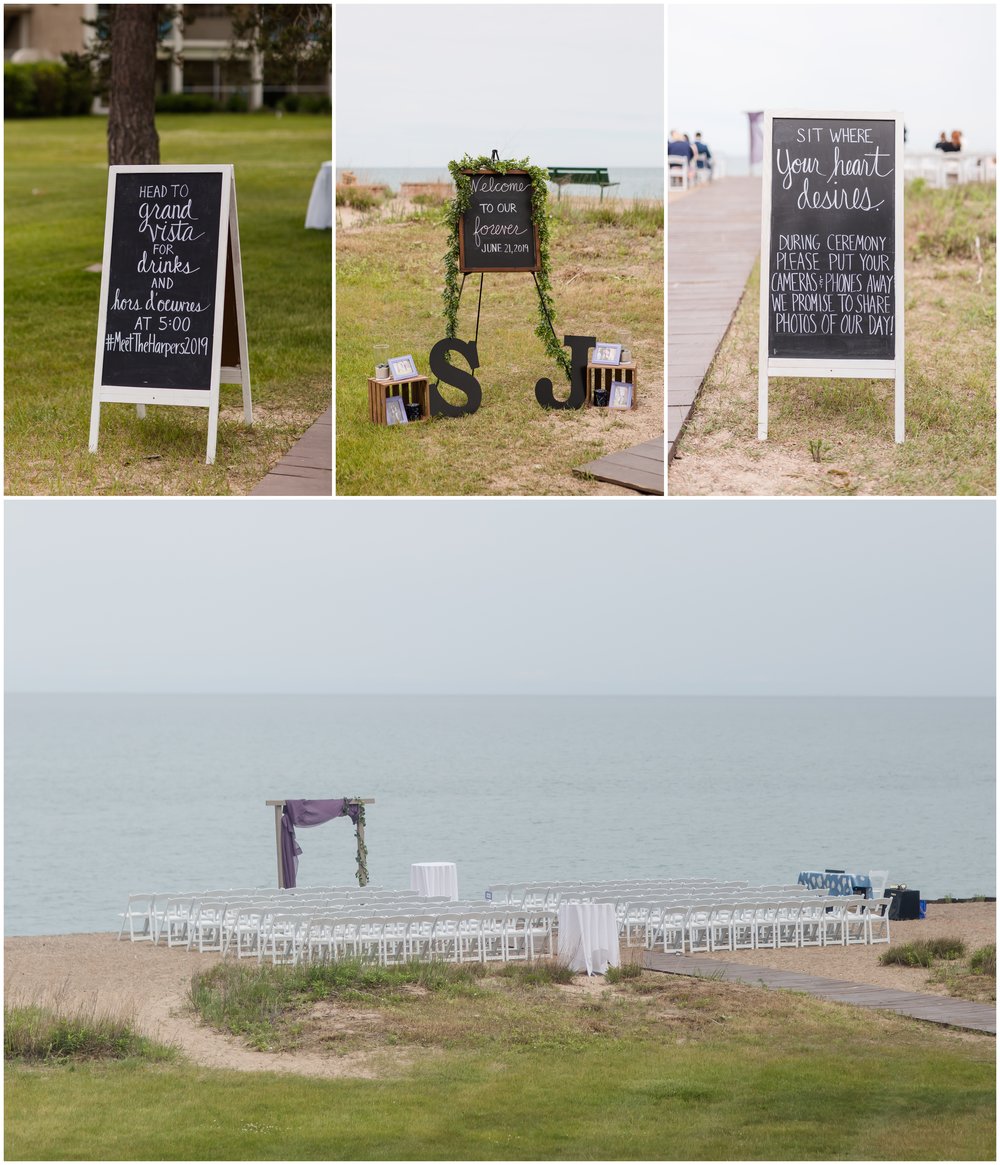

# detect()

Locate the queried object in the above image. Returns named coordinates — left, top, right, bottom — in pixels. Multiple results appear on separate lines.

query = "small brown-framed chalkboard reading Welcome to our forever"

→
left=458, top=170, right=541, bottom=273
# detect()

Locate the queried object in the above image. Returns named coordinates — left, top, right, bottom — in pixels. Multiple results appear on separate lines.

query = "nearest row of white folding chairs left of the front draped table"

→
left=258, top=908, right=555, bottom=963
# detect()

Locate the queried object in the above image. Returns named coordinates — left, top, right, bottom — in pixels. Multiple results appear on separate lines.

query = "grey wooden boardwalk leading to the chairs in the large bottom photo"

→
left=643, top=951, right=997, bottom=1036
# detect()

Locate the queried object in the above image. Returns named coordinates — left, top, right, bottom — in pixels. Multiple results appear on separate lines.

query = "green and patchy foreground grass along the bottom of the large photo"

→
left=5, top=973, right=995, bottom=1160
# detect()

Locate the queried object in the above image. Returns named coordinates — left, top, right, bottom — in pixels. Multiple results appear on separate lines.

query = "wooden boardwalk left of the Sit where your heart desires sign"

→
left=667, top=178, right=761, bottom=464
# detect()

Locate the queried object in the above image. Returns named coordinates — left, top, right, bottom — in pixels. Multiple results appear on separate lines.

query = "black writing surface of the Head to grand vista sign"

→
left=98, top=168, right=222, bottom=393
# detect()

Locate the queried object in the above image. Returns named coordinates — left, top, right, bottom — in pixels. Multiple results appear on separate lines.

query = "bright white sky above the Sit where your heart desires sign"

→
left=667, top=3, right=997, bottom=160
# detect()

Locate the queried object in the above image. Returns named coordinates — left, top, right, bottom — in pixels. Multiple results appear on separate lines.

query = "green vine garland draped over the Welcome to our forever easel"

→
left=442, top=154, right=572, bottom=381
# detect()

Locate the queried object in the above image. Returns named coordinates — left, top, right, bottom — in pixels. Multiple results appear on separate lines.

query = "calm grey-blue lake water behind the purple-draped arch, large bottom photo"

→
left=5, top=696, right=995, bottom=934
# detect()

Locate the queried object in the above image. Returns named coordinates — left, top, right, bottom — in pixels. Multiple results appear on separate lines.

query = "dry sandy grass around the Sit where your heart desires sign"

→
left=669, top=182, right=997, bottom=496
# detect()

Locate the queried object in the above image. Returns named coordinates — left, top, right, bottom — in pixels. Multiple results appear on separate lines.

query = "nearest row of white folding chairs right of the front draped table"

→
left=646, top=897, right=890, bottom=954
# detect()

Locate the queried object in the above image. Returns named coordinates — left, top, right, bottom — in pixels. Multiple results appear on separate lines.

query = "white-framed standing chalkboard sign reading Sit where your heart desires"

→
left=758, top=111, right=906, bottom=443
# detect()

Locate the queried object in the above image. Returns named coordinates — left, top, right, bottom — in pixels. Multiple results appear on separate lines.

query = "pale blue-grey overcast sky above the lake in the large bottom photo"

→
left=5, top=499, right=995, bottom=696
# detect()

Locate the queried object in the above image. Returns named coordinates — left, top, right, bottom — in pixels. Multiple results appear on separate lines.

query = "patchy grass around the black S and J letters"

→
left=336, top=199, right=663, bottom=495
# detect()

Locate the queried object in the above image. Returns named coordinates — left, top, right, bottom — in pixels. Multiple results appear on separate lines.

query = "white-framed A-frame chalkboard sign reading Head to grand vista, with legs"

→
left=90, top=164, right=253, bottom=465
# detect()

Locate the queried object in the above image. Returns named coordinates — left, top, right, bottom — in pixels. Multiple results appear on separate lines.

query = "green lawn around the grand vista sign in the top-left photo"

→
left=3, top=113, right=332, bottom=494
